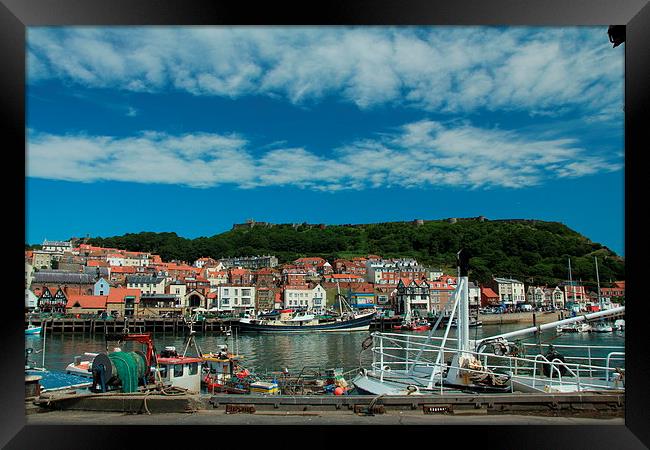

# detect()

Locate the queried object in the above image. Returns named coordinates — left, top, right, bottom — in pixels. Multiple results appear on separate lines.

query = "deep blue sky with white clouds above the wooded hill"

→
left=26, top=27, right=624, bottom=254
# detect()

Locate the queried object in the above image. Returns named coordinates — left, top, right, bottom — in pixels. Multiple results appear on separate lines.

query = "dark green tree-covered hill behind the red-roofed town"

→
left=83, top=219, right=625, bottom=285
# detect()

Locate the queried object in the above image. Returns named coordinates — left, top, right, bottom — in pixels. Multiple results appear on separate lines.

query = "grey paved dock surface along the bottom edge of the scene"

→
left=26, top=410, right=625, bottom=425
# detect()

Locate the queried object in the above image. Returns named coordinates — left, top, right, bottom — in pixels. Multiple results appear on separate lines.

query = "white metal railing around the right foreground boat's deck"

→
left=364, top=333, right=625, bottom=391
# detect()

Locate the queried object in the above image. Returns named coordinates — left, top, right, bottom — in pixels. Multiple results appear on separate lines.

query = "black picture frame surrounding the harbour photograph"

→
left=0, top=0, right=650, bottom=450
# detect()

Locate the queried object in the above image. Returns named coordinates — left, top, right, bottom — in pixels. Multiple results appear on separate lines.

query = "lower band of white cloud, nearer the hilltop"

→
left=27, top=120, right=622, bottom=191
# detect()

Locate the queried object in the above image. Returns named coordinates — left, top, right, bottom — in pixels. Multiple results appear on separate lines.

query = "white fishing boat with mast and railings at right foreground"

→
left=352, top=250, right=625, bottom=396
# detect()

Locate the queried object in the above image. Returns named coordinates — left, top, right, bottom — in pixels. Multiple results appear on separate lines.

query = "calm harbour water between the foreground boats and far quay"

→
left=25, top=324, right=625, bottom=373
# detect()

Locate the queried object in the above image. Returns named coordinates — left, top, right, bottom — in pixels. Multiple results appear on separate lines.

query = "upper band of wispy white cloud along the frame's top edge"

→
left=28, top=27, right=624, bottom=115
